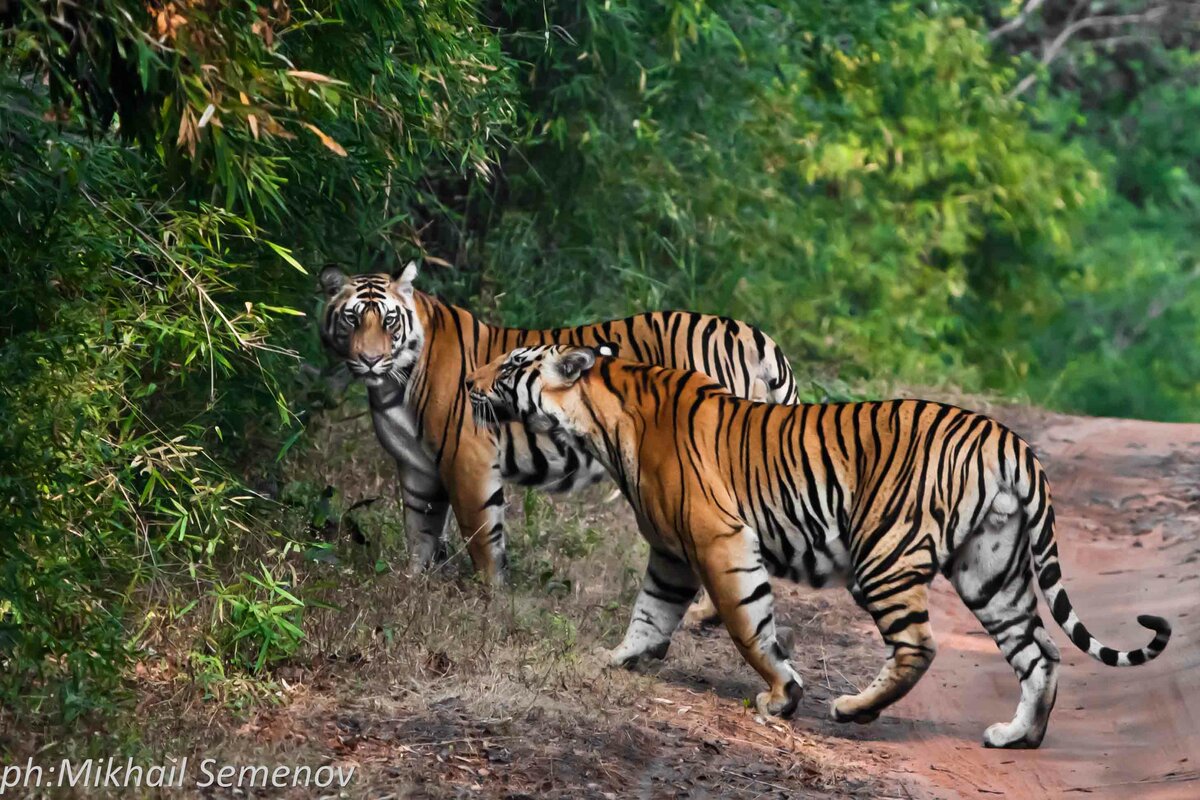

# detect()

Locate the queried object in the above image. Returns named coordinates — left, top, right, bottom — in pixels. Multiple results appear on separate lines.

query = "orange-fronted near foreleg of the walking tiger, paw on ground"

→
left=701, top=528, right=804, bottom=718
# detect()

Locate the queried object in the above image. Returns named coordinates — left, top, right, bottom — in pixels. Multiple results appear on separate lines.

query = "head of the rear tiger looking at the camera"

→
left=319, top=261, right=425, bottom=386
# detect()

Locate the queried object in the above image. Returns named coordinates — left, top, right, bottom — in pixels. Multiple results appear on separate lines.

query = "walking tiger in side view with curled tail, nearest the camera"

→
left=467, top=345, right=1171, bottom=747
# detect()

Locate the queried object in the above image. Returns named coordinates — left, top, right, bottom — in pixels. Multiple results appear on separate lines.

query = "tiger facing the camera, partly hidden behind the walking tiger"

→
left=319, top=263, right=796, bottom=585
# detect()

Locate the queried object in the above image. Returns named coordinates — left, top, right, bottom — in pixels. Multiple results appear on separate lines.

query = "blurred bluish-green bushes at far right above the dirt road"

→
left=984, top=28, right=1200, bottom=421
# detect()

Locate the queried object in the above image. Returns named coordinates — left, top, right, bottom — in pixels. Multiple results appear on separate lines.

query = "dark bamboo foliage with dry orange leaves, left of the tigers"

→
left=0, top=0, right=525, bottom=716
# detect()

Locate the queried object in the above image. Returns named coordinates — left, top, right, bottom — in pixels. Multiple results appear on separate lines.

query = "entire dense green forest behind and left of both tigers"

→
left=0, top=0, right=1200, bottom=718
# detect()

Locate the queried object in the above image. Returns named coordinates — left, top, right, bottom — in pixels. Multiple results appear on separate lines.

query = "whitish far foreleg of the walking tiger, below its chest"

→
left=606, top=549, right=700, bottom=667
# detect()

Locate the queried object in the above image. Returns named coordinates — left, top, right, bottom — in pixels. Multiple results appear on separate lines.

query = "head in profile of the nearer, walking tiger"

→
left=467, top=344, right=616, bottom=434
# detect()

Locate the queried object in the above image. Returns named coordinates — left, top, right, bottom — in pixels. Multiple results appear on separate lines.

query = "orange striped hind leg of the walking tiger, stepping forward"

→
left=829, top=572, right=937, bottom=723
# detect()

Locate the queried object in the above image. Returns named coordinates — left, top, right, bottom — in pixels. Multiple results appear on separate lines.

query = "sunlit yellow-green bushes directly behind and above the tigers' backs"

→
left=477, top=2, right=1100, bottom=381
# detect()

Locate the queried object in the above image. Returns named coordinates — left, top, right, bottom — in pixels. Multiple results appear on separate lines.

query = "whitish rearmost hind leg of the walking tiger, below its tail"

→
left=947, top=503, right=1060, bottom=748
